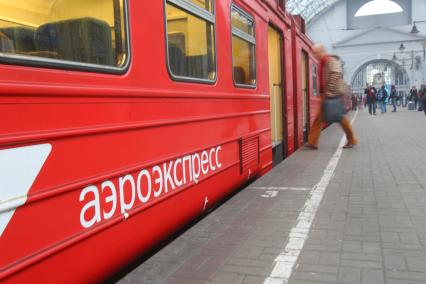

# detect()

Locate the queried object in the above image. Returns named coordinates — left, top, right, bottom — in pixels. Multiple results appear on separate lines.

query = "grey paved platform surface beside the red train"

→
left=118, top=109, right=426, bottom=284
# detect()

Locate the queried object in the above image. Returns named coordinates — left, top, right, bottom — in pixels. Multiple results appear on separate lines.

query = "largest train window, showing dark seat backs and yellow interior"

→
left=0, top=0, right=127, bottom=67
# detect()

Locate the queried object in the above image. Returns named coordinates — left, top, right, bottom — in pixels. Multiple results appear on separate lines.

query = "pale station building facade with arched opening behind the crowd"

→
left=307, top=0, right=426, bottom=95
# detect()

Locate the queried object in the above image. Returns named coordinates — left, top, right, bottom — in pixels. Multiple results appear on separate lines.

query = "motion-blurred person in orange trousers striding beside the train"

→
left=306, top=45, right=358, bottom=149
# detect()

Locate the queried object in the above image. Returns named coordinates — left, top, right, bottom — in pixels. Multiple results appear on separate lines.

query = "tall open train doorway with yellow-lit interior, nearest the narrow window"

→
left=268, top=26, right=287, bottom=165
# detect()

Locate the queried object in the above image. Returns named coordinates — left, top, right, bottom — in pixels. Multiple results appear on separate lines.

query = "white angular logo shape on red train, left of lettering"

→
left=0, top=144, right=52, bottom=237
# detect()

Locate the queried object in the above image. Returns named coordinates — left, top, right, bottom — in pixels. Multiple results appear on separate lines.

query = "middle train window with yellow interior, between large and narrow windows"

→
left=166, top=0, right=216, bottom=81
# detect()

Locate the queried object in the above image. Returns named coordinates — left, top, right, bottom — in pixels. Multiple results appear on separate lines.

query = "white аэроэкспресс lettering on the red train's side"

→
left=79, top=146, right=222, bottom=228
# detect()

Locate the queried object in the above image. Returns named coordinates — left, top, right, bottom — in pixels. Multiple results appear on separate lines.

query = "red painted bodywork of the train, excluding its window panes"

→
left=0, top=0, right=319, bottom=283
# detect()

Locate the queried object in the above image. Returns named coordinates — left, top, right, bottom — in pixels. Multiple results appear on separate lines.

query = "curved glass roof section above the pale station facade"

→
left=286, top=0, right=339, bottom=23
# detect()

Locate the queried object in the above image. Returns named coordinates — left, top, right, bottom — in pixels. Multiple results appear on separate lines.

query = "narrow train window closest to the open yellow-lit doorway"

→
left=231, top=5, right=256, bottom=87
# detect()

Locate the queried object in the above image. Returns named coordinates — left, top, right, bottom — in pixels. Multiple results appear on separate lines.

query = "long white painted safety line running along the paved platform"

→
left=263, top=111, right=358, bottom=284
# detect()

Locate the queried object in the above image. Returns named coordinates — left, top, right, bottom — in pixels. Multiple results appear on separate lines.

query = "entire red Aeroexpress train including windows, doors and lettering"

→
left=0, top=0, right=319, bottom=283
